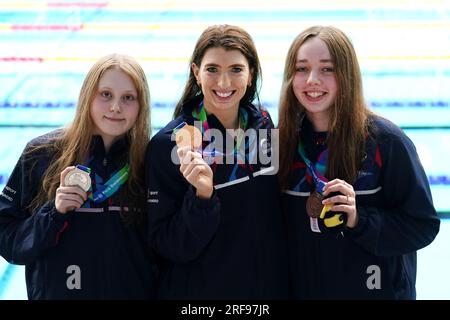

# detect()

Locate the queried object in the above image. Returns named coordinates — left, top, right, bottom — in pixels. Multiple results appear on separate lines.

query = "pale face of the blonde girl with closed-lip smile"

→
left=90, top=69, right=139, bottom=150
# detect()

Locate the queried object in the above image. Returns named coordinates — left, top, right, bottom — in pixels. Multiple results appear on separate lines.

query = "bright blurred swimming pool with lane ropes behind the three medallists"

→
left=0, top=0, right=450, bottom=299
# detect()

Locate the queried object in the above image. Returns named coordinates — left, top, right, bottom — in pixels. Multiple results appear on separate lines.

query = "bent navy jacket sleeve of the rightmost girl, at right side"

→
left=347, top=129, right=440, bottom=256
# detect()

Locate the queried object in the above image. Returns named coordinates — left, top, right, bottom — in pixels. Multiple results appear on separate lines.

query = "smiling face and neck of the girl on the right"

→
left=292, top=37, right=338, bottom=131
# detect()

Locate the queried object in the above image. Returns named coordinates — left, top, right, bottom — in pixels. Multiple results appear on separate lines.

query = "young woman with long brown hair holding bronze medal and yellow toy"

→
left=279, top=26, right=439, bottom=299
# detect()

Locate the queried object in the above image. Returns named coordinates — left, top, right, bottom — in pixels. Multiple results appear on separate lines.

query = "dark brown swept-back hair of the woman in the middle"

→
left=173, top=24, right=261, bottom=118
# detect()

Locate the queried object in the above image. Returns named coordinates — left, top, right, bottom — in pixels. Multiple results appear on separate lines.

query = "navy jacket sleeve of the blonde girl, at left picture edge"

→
left=0, top=145, right=70, bottom=264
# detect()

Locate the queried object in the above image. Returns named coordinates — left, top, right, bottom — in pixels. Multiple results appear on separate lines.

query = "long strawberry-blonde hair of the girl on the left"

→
left=30, top=54, right=150, bottom=222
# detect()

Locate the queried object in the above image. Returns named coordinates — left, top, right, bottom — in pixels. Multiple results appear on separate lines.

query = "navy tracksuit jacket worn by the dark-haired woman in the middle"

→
left=146, top=100, right=288, bottom=299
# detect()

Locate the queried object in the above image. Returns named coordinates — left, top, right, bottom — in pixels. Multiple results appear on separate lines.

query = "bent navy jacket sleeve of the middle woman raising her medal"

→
left=146, top=135, right=220, bottom=263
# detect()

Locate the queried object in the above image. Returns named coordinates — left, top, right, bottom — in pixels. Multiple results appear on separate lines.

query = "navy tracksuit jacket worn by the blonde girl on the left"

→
left=0, top=131, right=156, bottom=299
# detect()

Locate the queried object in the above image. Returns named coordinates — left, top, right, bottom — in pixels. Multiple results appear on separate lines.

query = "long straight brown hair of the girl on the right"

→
left=278, top=26, right=372, bottom=189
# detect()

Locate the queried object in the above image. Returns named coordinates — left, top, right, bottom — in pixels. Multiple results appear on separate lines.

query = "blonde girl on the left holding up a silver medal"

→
left=0, top=54, right=155, bottom=299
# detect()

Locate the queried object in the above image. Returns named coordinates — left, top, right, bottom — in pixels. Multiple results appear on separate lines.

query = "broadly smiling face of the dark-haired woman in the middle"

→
left=192, top=47, right=252, bottom=122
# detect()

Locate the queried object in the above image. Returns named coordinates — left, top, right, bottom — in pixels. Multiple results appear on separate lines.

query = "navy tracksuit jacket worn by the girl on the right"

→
left=282, top=118, right=439, bottom=299
